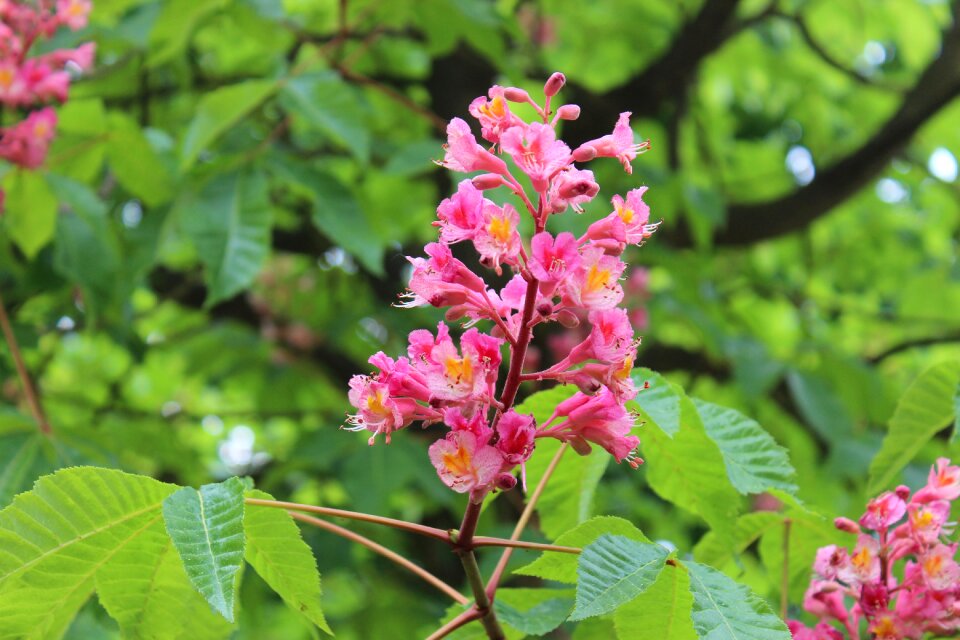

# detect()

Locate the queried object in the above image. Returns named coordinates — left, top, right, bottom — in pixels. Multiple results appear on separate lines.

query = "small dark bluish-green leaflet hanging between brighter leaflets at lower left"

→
left=163, top=478, right=244, bottom=622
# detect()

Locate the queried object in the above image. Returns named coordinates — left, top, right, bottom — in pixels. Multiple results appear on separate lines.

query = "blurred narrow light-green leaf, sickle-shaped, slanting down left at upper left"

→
left=180, top=80, right=279, bottom=172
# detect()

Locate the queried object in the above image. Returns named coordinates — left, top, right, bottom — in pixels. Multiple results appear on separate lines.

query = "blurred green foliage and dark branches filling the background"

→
left=0, top=0, right=960, bottom=640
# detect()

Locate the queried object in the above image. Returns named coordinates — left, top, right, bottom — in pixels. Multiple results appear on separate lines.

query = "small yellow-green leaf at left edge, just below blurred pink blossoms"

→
left=2, top=168, right=57, bottom=260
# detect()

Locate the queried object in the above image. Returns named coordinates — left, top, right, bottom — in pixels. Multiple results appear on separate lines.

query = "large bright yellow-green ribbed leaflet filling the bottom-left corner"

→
left=0, top=467, right=176, bottom=639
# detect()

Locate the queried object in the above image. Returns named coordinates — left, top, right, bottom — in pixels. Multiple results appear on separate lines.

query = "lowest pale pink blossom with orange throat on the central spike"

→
left=429, top=431, right=503, bottom=493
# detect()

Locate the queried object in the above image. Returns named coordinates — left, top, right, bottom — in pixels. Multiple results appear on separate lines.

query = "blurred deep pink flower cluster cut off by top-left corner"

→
left=0, top=0, right=94, bottom=175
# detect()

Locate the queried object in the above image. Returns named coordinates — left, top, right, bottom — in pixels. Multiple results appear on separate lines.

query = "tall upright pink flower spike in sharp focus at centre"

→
left=348, top=73, right=657, bottom=501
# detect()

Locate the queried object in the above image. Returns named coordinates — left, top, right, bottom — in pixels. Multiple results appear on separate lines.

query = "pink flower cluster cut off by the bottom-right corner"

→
left=789, top=458, right=960, bottom=640
